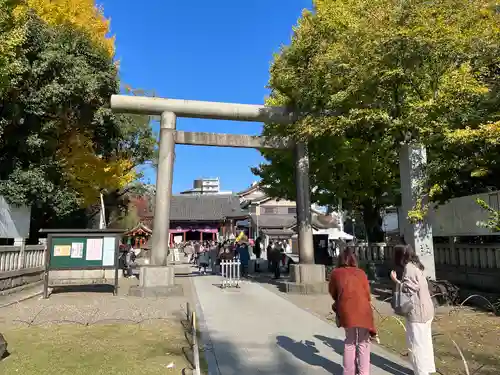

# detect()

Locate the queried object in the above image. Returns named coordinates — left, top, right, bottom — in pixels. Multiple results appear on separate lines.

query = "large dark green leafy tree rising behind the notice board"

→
left=0, top=13, right=154, bottom=237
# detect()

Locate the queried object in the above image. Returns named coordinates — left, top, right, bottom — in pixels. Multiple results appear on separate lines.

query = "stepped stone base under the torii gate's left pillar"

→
left=129, top=266, right=184, bottom=297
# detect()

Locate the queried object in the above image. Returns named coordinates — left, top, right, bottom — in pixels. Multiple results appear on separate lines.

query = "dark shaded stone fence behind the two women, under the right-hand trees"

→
left=355, top=242, right=500, bottom=293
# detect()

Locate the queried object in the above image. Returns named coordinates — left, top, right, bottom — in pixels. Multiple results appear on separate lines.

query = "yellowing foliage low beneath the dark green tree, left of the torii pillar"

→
left=57, top=132, right=137, bottom=207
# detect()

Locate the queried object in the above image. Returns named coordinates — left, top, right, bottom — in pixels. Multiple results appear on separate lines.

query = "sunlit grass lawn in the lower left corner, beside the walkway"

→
left=0, top=322, right=191, bottom=375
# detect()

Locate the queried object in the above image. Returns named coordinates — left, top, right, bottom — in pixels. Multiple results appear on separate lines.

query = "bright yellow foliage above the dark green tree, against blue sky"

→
left=16, top=0, right=115, bottom=56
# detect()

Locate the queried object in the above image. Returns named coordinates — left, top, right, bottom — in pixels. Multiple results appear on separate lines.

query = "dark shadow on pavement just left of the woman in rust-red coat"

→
left=276, top=336, right=343, bottom=374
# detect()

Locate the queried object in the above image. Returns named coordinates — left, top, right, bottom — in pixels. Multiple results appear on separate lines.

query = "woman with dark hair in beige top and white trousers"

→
left=391, top=245, right=436, bottom=375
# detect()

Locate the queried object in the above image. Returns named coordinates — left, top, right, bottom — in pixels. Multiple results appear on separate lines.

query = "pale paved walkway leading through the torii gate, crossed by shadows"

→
left=193, top=276, right=412, bottom=375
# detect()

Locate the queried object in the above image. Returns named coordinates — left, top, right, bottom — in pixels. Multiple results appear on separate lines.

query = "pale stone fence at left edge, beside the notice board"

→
left=0, top=245, right=45, bottom=294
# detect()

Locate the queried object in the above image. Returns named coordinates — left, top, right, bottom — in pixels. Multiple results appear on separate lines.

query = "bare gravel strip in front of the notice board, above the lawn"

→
left=0, top=270, right=197, bottom=327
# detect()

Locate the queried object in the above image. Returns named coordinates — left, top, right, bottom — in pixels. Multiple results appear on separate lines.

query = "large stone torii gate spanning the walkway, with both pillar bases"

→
left=111, top=95, right=332, bottom=296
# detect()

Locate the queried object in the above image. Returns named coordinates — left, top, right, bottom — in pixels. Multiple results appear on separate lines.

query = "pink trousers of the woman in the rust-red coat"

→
left=344, top=328, right=370, bottom=375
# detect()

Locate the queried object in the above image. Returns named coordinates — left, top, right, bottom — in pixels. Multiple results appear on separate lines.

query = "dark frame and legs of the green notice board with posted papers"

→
left=39, top=229, right=124, bottom=299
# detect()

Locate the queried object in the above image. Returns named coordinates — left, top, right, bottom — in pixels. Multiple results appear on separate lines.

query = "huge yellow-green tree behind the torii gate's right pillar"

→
left=255, top=0, right=500, bottom=240
